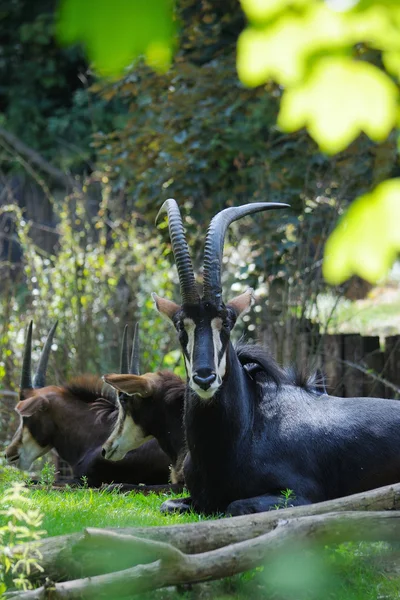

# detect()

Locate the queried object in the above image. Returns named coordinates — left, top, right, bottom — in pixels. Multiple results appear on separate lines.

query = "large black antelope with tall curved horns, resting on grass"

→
left=154, top=200, right=400, bottom=515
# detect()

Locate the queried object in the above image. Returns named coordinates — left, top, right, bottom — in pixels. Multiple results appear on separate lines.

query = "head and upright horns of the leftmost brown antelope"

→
left=6, top=321, right=57, bottom=470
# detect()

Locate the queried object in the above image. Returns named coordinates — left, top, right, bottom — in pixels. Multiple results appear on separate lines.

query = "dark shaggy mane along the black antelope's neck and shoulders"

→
left=235, top=343, right=326, bottom=394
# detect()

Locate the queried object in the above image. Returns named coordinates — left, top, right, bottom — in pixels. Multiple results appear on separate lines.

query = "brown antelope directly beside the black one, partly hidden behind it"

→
left=103, top=324, right=186, bottom=484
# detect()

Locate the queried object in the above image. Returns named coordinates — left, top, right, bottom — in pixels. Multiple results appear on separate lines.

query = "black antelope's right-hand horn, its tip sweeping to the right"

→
left=203, top=202, right=289, bottom=307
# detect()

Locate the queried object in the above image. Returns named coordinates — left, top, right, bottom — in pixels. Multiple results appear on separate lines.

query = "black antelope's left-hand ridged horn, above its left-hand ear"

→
left=156, top=198, right=200, bottom=304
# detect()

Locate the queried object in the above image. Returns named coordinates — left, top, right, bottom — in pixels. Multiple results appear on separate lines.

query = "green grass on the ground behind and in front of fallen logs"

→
left=0, top=469, right=400, bottom=600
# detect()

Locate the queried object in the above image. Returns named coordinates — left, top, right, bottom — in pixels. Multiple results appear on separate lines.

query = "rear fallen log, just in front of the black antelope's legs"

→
left=12, top=484, right=400, bottom=581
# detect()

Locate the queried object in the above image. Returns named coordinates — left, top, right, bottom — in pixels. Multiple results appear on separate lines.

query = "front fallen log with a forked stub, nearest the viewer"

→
left=8, top=511, right=400, bottom=600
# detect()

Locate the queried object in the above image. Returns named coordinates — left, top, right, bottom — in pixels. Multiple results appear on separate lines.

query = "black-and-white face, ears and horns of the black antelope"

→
left=153, top=199, right=288, bottom=400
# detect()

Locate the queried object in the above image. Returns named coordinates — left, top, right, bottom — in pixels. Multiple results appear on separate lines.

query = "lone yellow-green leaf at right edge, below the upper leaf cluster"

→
left=323, top=179, right=400, bottom=285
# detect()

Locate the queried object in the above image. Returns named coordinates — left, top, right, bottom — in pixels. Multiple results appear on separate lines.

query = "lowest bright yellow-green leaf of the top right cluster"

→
left=278, top=58, right=399, bottom=154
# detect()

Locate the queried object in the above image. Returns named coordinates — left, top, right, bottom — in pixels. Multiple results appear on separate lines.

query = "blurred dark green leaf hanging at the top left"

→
left=57, top=0, right=174, bottom=75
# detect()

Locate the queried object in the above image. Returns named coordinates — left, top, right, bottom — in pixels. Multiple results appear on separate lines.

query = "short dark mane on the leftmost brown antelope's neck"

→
left=64, top=375, right=117, bottom=417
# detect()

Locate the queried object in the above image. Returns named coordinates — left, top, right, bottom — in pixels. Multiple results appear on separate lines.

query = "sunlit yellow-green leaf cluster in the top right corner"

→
left=238, top=0, right=400, bottom=153
